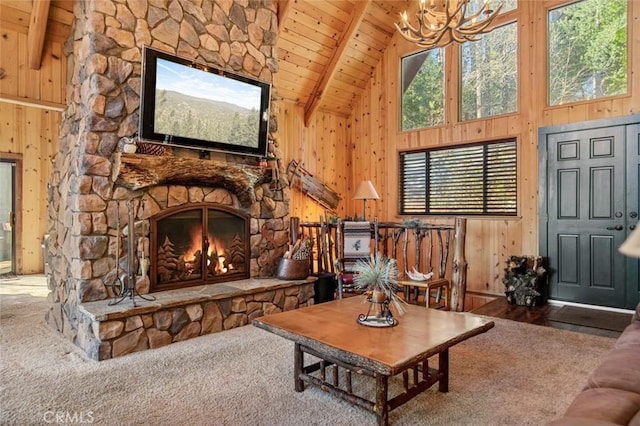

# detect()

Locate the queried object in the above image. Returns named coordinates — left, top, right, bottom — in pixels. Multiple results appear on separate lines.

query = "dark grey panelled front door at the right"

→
left=540, top=116, right=639, bottom=308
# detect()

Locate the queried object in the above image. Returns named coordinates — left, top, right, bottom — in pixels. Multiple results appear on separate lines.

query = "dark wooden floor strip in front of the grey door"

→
left=472, top=297, right=620, bottom=338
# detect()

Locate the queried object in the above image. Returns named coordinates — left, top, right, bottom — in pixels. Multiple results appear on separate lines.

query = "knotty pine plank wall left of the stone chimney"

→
left=0, top=26, right=67, bottom=274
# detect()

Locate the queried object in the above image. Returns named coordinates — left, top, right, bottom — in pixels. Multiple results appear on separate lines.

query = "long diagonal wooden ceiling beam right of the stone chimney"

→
left=304, top=1, right=369, bottom=126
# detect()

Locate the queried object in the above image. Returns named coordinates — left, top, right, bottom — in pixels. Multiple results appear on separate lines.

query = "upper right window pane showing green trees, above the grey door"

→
left=548, top=0, right=627, bottom=105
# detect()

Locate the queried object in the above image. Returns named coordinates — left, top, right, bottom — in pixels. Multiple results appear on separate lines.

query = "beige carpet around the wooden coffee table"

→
left=0, top=282, right=614, bottom=426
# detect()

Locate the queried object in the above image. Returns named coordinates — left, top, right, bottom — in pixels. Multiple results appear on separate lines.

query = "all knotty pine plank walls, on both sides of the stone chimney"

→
left=0, top=0, right=640, bottom=286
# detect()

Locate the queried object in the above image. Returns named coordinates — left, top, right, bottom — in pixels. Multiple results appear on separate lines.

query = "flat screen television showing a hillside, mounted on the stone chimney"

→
left=140, top=47, right=271, bottom=156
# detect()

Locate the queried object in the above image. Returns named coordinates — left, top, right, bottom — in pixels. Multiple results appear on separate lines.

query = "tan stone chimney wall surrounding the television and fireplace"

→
left=47, top=0, right=289, bottom=350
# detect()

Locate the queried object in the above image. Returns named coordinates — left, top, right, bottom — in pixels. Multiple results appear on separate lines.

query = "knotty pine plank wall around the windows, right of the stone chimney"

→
left=279, top=0, right=640, bottom=295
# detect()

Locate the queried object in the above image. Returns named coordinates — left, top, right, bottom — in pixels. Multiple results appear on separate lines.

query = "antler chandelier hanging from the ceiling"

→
left=395, top=0, right=502, bottom=48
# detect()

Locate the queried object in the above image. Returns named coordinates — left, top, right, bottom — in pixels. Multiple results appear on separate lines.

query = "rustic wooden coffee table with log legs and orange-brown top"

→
left=253, top=296, right=494, bottom=425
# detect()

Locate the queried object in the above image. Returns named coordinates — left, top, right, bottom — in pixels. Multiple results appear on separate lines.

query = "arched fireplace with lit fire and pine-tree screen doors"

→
left=149, top=203, right=250, bottom=292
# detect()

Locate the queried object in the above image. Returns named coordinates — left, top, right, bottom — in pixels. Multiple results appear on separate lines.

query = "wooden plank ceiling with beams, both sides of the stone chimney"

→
left=0, top=0, right=411, bottom=122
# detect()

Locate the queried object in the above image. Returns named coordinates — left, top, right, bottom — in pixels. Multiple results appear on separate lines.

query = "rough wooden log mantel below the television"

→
left=113, top=152, right=271, bottom=207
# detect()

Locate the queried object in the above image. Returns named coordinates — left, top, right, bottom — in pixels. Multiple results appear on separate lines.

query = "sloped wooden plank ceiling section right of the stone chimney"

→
left=274, top=0, right=409, bottom=123
